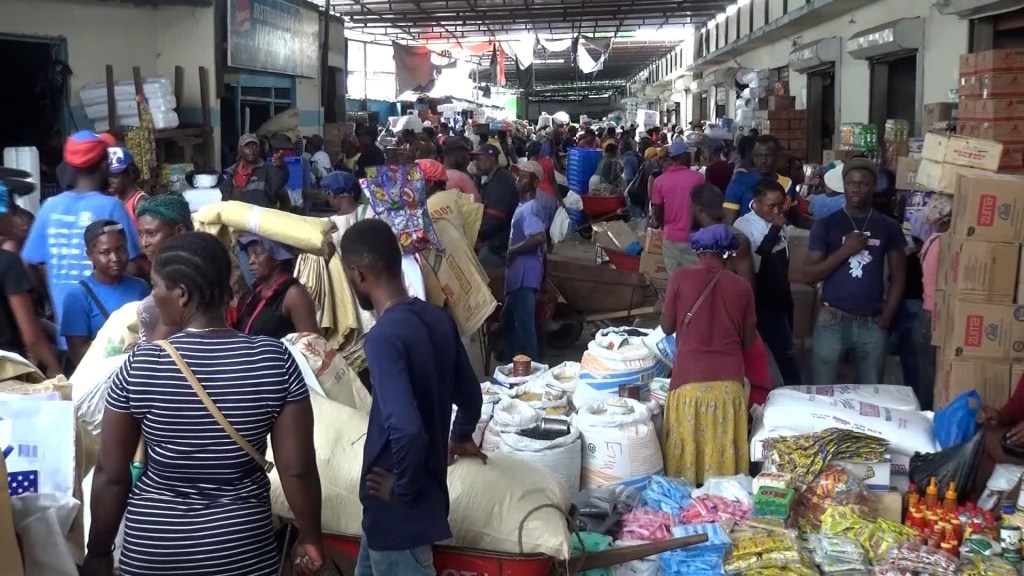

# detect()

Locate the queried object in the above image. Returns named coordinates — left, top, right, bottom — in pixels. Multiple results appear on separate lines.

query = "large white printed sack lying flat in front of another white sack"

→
left=764, top=390, right=938, bottom=455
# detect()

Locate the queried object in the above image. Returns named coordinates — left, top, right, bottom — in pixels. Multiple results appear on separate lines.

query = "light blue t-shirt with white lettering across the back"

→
left=22, top=192, right=140, bottom=349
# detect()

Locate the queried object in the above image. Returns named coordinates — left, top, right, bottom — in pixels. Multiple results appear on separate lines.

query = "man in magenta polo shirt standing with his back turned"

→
left=651, top=141, right=703, bottom=275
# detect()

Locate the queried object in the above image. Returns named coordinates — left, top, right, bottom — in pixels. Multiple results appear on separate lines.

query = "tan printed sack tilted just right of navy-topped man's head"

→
left=420, top=220, right=498, bottom=335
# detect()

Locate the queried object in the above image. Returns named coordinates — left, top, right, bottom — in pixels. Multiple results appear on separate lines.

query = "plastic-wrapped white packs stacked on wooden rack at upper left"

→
left=80, top=76, right=178, bottom=132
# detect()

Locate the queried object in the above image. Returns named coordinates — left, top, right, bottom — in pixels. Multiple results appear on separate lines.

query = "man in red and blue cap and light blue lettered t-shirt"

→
left=22, top=130, right=141, bottom=360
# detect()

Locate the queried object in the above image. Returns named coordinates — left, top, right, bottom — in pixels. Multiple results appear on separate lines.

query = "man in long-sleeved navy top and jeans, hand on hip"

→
left=340, top=219, right=486, bottom=576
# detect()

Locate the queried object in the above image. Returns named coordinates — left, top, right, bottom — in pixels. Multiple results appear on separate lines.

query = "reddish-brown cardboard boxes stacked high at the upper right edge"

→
left=956, top=49, right=1024, bottom=172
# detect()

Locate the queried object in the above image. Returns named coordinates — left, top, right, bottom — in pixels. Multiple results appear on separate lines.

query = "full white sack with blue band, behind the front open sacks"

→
left=572, top=327, right=669, bottom=408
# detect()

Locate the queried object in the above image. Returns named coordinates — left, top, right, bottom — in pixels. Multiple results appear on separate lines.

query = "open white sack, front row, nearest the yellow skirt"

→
left=577, top=398, right=665, bottom=489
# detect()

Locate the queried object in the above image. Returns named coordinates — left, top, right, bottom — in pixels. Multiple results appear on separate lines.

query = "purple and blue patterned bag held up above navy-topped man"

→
left=360, top=164, right=440, bottom=250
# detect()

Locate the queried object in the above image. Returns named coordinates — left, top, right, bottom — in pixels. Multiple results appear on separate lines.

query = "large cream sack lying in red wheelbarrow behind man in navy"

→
left=267, top=394, right=569, bottom=560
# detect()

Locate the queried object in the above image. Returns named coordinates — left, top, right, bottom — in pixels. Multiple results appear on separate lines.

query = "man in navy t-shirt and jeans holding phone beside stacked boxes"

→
left=804, top=158, right=906, bottom=385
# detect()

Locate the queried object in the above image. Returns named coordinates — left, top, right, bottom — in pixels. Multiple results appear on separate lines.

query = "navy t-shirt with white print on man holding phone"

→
left=807, top=210, right=906, bottom=318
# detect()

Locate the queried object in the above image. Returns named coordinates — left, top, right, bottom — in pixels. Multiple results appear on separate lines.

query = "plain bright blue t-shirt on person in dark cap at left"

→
left=60, top=275, right=150, bottom=340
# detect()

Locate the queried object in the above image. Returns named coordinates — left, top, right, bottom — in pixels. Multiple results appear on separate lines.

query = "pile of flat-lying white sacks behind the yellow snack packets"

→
left=751, top=384, right=938, bottom=461
